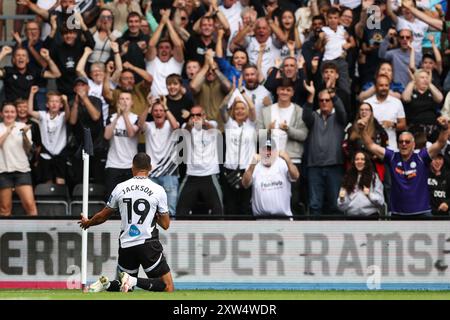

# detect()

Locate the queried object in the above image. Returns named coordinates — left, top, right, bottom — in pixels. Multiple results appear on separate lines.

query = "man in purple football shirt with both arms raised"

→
left=358, top=117, right=448, bottom=218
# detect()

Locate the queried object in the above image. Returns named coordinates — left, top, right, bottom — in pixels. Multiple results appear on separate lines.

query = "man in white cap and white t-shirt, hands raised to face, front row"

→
left=242, top=140, right=300, bottom=219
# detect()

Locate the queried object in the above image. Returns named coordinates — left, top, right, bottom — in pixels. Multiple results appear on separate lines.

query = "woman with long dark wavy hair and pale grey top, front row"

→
left=337, top=151, right=384, bottom=217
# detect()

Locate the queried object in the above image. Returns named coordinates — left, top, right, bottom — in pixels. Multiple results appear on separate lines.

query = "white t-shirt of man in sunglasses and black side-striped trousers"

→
left=183, top=120, right=222, bottom=177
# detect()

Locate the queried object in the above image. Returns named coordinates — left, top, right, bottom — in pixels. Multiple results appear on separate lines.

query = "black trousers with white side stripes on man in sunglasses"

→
left=176, top=175, right=223, bottom=216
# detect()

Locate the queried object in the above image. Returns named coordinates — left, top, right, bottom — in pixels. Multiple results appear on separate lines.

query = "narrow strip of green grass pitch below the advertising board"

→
left=0, top=290, right=450, bottom=300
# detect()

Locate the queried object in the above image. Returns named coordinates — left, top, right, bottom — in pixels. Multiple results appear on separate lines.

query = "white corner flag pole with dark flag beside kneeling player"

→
left=81, top=128, right=94, bottom=292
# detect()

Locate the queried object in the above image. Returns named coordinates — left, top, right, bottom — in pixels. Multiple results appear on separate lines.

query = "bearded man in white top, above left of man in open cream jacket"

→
left=242, top=64, right=272, bottom=115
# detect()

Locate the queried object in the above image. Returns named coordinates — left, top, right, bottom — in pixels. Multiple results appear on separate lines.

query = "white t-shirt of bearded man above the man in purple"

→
left=364, top=95, right=405, bottom=151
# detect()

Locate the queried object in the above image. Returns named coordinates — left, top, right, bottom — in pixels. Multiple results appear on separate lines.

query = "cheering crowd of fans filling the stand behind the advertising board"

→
left=0, top=0, right=450, bottom=218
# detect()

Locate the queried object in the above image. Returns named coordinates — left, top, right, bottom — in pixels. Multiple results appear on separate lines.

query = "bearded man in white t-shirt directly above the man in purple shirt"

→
left=364, top=75, right=406, bottom=150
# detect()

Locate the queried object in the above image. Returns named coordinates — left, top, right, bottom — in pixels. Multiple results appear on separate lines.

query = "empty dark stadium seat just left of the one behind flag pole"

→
left=34, top=183, right=69, bottom=217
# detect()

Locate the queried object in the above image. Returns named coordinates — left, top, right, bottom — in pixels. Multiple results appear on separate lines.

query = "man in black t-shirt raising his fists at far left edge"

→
left=0, top=46, right=61, bottom=101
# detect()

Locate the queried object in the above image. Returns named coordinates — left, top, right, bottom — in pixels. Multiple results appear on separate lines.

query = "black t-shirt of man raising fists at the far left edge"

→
left=3, top=66, right=44, bottom=102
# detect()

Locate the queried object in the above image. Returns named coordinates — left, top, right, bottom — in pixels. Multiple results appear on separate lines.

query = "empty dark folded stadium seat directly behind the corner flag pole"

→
left=70, top=183, right=105, bottom=216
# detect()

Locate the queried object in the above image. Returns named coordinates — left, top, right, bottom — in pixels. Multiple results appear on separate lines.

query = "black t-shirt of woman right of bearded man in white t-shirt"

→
left=405, top=90, right=438, bottom=125
